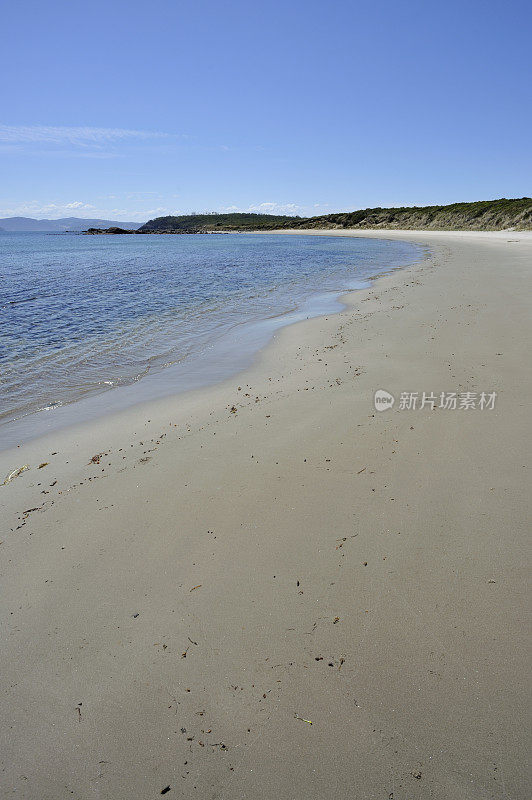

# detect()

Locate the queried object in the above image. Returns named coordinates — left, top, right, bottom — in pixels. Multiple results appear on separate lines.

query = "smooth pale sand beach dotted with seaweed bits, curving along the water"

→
left=0, top=231, right=532, bottom=800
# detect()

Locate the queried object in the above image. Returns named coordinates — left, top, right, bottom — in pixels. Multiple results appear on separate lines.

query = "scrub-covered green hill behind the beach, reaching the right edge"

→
left=137, top=197, right=532, bottom=233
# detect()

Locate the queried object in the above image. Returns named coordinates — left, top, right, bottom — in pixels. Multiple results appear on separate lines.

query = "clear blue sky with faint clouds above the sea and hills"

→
left=0, top=0, right=532, bottom=220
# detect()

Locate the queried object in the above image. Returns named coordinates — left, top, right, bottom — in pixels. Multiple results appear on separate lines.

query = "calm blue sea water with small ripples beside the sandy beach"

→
left=0, top=233, right=422, bottom=438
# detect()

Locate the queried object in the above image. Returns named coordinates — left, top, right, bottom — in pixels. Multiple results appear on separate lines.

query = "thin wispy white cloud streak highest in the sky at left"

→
left=0, top=123, right=169, bottom=147
